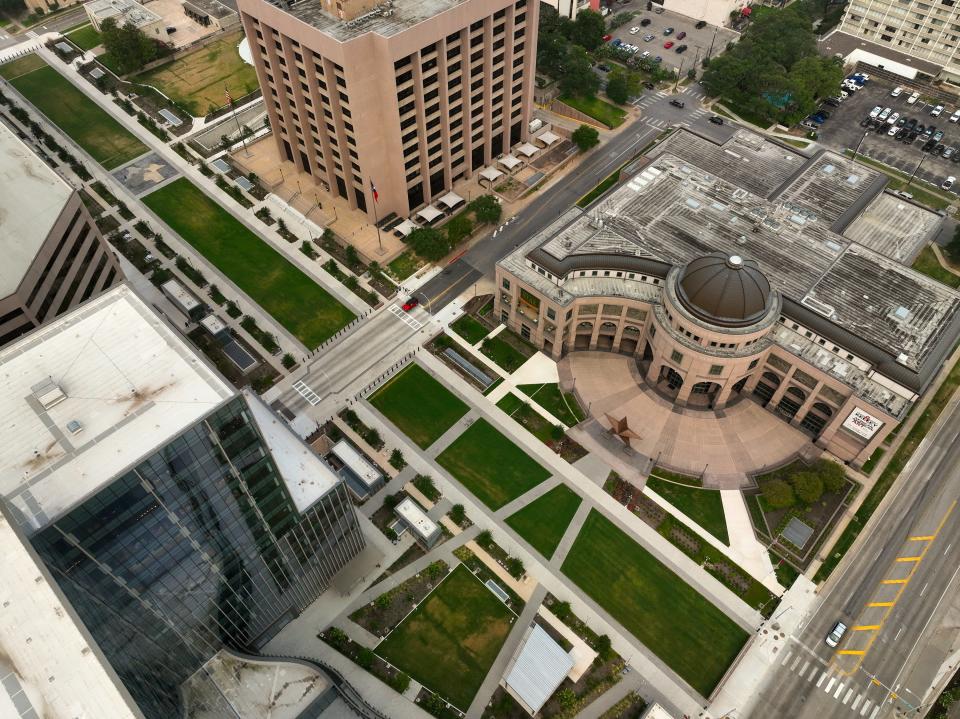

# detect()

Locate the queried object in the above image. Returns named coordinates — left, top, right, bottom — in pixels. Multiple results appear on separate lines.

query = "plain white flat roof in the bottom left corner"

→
left=0, top=511, right=143, bottom=719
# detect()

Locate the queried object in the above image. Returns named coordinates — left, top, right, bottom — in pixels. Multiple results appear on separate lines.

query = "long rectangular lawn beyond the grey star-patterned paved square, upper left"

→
left=10, top=63, right=147, bottom=170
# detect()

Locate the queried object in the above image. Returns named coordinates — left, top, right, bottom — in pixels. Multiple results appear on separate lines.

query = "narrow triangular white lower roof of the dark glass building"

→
left=243, top=390, right=340, bottom=512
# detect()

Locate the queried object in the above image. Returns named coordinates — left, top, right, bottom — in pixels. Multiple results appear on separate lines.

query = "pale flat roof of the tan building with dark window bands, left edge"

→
left=0, top=124, right=73, bottom=297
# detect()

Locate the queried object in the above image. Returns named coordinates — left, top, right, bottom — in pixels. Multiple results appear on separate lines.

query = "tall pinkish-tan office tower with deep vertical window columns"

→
left=238, top=0, right=539, bottom=219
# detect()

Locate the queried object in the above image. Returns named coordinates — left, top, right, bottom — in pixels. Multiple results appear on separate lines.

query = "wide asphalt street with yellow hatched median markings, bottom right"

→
left=751, top=394, right=960, bottom=719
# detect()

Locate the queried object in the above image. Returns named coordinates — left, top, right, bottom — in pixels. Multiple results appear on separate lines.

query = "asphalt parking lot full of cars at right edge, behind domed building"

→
left=819, top=73, right=960, bottom=193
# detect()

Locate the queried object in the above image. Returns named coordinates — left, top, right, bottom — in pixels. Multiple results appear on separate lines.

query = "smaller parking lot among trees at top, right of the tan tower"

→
left=606, top=0, right=739, bottom=73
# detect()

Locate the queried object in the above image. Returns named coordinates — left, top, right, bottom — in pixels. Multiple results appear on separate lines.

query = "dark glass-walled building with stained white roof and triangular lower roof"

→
left=0, top=286, right=364, bottom=719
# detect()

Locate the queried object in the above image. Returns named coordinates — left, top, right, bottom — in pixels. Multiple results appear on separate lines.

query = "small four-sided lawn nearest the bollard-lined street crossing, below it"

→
left=370, top=364, right=469, bottom=449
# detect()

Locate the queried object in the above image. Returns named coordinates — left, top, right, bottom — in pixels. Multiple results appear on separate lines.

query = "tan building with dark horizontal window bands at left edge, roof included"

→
left=0, top=120, right=123, bottom=347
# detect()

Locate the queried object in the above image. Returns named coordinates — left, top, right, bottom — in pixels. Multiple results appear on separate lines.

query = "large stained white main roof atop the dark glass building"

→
left=0, top=285, right=234, bottom=529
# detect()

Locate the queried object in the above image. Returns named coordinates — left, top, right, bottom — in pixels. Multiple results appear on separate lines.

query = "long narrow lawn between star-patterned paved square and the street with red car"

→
left=143, top=177, right=355, bottom=349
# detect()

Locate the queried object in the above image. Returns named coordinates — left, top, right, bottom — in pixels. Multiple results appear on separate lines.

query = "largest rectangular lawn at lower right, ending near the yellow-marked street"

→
left=562, top=510, right=748, bottom=697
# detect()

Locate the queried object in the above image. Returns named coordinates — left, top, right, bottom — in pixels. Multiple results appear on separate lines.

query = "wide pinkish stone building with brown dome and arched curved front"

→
left=495, top=130, right=960, bottom=466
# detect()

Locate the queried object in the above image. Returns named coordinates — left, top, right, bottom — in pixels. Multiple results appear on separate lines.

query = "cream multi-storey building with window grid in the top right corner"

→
left=838, top=0, right=960, bottom=84
